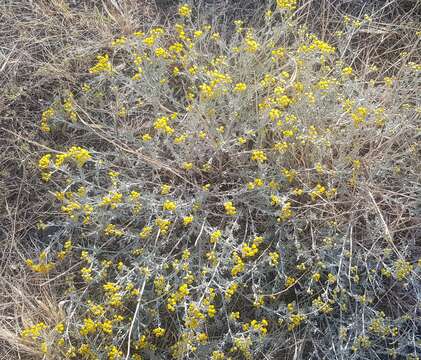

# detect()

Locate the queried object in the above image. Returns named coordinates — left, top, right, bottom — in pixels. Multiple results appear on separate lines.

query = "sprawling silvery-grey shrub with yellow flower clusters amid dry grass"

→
left=18, top=0, right=420, bottom=360
